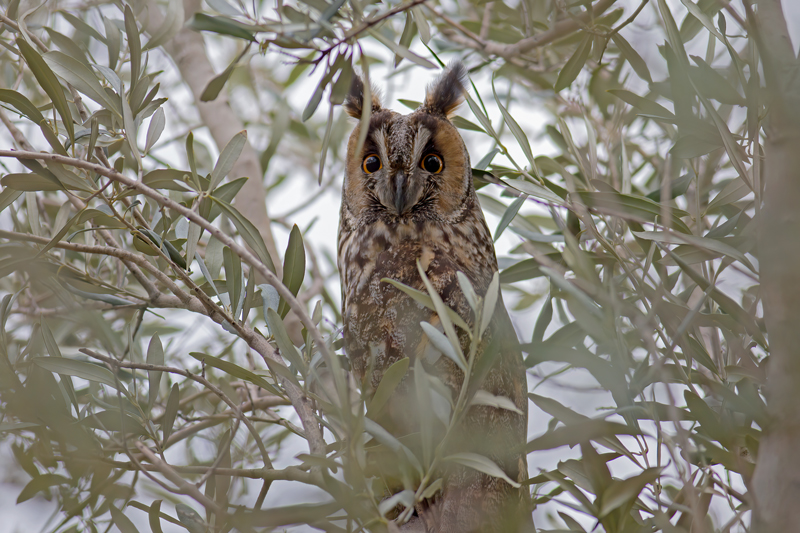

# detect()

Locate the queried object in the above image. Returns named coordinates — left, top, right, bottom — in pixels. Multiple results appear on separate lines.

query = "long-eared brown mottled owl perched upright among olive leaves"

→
left=338, top=62, right=532, bottom=533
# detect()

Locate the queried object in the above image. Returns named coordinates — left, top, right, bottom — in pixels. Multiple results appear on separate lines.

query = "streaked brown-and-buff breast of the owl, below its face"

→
left=339, top=216, right=496, bottom=385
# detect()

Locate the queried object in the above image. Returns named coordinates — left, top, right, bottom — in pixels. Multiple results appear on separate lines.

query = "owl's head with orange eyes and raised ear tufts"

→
left=342, top=62, right=475, bottom=224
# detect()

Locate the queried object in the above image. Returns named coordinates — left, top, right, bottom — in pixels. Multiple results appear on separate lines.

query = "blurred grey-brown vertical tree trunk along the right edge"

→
left=749, top=0, right=800, bottom=533
